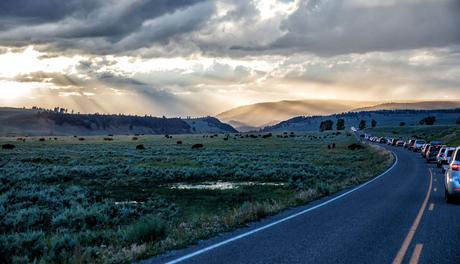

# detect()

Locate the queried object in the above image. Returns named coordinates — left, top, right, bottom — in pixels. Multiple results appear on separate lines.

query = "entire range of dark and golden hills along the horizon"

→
left=0, top=100, right=460, bottom=136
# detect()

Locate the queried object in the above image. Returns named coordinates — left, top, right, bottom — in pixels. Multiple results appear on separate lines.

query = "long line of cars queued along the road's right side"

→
left=361, top=134, right=460, bottom=203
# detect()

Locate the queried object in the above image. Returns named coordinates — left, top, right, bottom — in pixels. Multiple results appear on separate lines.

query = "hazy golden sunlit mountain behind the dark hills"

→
left=217, top=100, right=460, bottom=131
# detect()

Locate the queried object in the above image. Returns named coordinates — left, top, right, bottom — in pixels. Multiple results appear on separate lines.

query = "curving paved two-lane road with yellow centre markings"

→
left=145, top=147, right=460, bottom=264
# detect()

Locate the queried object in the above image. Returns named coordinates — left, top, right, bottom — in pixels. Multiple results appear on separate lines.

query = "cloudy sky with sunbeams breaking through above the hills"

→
left=0, top=0, right=460, bottom=116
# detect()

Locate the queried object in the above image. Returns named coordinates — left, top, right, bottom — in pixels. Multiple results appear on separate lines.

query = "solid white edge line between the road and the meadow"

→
left=166, top=151, right=398, bottom=264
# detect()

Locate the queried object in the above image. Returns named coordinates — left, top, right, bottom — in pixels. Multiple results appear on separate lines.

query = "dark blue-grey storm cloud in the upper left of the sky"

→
left=0, top=0, right=212, bottom=53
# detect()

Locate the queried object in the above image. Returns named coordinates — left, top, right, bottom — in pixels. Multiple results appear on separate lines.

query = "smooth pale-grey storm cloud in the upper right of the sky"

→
left=232, top=0, right=460, bottom=55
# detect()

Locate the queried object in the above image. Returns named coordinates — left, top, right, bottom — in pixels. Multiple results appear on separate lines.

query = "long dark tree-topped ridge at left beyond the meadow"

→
left=0, top=108, right=238, bottom=136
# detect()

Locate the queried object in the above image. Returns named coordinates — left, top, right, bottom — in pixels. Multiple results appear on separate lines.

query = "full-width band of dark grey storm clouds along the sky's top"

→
left=0, top=0, right=460, bottom=57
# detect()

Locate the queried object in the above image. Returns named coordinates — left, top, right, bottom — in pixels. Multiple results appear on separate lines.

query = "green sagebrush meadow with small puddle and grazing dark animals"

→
left=0, top=132, right=393, bottom=263
